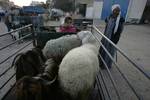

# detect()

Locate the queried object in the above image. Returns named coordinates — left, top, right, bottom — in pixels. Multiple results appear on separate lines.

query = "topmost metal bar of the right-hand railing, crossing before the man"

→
left=93, top=26, right=150, bottom=80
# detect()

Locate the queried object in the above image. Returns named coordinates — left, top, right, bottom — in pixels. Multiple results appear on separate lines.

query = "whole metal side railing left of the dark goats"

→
left=0, top=24, right=35, bottom=100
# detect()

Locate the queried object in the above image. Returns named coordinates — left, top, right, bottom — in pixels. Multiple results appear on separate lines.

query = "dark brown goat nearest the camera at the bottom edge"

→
left=14, top=76, right=69, bottom=100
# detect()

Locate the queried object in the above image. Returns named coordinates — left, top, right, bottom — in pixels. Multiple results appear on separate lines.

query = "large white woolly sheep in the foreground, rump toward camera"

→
left=58, top=31, right=99, bottom=100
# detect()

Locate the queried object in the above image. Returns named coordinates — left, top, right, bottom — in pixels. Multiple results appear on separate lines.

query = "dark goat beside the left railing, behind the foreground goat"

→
left=12, top=48, right=46, bottom=80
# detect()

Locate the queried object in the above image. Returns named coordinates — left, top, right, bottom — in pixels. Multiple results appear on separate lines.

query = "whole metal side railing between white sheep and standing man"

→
left=93, top=26, right=150, bottom=100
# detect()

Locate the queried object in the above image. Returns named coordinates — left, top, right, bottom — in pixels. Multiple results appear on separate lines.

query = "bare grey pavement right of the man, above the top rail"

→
left=118, top=25, right=150, bottom=72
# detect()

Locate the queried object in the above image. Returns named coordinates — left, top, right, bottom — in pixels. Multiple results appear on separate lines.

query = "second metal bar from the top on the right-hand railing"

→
left=95, top=30, right=140, bottom=100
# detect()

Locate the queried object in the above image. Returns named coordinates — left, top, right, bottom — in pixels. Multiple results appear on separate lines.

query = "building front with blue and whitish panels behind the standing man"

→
left=82, top=0, right=150, bottom=23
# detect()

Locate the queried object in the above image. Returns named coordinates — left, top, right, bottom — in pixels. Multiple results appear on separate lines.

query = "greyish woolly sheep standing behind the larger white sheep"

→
left=43, top=35, right=81, bottom=63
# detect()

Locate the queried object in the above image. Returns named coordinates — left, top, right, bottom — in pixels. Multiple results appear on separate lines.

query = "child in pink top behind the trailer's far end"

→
left=59, top=17, right=76, bottom=33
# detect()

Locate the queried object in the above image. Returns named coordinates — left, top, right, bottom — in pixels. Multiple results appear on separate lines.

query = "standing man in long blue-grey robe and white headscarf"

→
left=99, top=4, right=124, bottom=69
